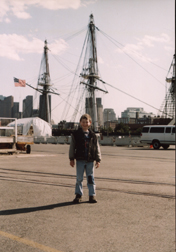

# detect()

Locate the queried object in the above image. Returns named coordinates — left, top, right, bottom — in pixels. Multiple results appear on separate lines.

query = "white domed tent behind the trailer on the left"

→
left=8, top=117, right=52, bottom=136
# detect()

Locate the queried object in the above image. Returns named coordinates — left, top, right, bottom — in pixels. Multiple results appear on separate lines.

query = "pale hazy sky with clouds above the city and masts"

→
left=0, top=0, right=175, bottom=123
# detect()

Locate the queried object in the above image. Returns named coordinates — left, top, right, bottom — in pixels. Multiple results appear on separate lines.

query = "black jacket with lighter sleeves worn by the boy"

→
left=69, top=128, right=101, bottom=162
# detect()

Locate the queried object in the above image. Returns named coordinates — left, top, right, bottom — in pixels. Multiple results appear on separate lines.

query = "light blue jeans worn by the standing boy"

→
left=75, top=160, right=95, bottom=196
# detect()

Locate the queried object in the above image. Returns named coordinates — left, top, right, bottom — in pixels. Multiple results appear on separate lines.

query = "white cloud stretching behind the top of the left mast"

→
left=0, top=34, right=68, bottom=61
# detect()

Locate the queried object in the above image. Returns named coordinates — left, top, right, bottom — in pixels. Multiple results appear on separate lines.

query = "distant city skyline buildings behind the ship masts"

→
left=0, top=95, right=156, bottom=127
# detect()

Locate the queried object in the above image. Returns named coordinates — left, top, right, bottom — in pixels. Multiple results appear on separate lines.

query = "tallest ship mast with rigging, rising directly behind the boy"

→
left=80, top=14, right=107, bottom=132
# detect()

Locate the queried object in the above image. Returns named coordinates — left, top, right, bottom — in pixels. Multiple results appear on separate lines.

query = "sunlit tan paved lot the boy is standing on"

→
left=0, top=144, right=175, bottom=252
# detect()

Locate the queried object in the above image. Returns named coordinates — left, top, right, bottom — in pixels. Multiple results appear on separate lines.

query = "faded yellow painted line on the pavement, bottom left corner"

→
left=0, top=231, right=62, bottom=252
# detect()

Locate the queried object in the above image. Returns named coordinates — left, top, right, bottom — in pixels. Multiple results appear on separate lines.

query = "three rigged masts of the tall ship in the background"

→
left=20, top=14, right=176, bottom=129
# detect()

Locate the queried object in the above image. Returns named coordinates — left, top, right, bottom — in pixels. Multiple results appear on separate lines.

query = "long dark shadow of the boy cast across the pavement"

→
left=0, top=201, right=87, bottom=215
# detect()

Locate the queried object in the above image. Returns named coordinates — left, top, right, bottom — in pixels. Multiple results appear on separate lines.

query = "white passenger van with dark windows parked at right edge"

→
left=140, top=125, right=175, bottom=150
